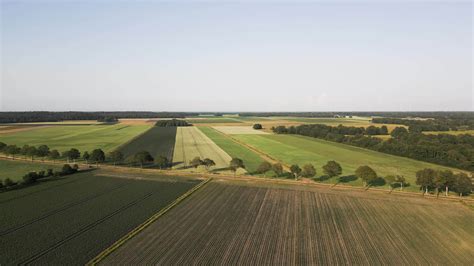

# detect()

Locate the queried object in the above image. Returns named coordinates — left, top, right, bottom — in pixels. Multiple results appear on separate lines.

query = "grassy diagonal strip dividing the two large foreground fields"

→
left=86, top=178, right=212, bottom=265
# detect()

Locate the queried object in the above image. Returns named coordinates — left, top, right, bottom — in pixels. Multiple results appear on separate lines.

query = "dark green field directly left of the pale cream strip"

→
left=119, top=126, right=176, bottom=161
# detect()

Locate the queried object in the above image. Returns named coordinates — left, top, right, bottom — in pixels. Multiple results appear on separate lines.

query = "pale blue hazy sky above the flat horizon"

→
left=0, top=0, right=474, bottom=111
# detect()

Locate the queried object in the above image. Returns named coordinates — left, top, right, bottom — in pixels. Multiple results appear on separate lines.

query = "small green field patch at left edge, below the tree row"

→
left=0, top=160, right=61, bottom=181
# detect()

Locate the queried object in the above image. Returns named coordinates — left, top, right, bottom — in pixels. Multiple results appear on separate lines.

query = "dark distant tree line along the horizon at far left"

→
left=0, top=112, right=199, bottom=123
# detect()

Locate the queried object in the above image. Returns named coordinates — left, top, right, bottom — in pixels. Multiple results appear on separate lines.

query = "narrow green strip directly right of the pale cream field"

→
left=199, top=127, right=263, bottom=173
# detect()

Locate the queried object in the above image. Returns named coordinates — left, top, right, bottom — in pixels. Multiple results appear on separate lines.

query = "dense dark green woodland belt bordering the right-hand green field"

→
left=272, top=124, right=474, bottom=171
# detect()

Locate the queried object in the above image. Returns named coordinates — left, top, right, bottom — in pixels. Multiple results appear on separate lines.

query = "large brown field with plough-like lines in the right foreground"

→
left=102, top=181, right=474, bottom=265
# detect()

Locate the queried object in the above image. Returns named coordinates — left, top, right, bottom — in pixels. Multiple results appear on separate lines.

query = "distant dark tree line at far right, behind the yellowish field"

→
left=372, top=118, right=474, bottom=132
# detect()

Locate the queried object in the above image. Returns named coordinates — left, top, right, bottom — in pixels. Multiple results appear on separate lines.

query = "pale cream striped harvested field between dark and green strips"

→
left=173, top=127, right=232, bottom=169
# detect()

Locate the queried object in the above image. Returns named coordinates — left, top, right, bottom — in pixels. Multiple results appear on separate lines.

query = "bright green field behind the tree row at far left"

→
left=0, top=124, right=150, bottom=152
